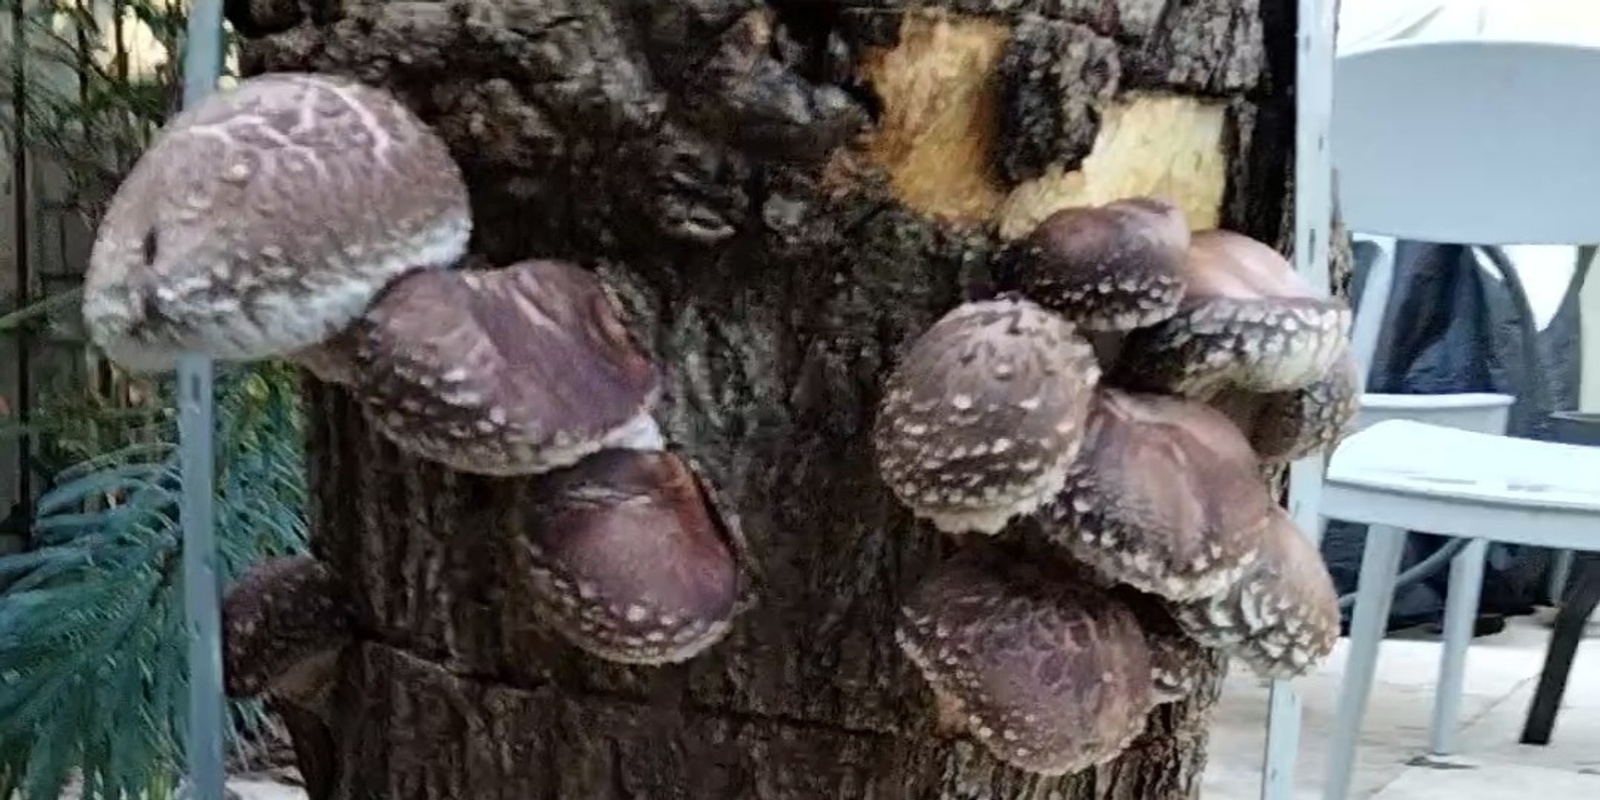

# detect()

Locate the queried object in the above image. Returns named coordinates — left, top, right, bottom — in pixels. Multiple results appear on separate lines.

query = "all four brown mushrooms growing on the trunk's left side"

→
left=83, top=74, right=747, bottom=678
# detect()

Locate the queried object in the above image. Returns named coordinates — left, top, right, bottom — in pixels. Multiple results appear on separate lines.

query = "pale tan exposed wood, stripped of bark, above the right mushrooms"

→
left=861, top=10, right=1229, bottom=238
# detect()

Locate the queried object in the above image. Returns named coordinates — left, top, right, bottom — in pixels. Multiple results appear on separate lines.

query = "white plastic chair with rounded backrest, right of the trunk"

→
left=1305, top=40, right=1600, bottom=800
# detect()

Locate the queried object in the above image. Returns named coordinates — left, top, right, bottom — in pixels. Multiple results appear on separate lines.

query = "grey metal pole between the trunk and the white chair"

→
left=1261, top=0, right=1339, bottom=800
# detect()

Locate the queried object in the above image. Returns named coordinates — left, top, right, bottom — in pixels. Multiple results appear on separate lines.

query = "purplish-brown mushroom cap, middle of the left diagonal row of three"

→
left=350, top=261, right=664, bottom=475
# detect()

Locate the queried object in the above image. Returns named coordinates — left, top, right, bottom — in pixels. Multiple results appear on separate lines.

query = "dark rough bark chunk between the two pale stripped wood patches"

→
left=995, top=16, right=1122, bottom=182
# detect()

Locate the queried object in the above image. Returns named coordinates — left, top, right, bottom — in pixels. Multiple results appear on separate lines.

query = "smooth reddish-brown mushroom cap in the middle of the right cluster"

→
left=1038, top=387, right=1275, bottom=600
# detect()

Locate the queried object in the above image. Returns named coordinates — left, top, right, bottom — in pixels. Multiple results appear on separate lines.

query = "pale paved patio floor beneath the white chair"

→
left=1202, top=618, right=1600, bottom=800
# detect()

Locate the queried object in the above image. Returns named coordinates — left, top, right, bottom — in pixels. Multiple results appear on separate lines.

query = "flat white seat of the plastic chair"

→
left=1328, top=419, right=1600, bottom=514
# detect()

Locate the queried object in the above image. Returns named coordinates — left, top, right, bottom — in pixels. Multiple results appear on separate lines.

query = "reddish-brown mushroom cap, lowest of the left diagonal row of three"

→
left=515, top=450, right=742, bottom=664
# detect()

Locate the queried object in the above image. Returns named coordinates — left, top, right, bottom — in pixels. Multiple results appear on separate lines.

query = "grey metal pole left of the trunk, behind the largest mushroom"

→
left=178, top=0, right=224, bottom=800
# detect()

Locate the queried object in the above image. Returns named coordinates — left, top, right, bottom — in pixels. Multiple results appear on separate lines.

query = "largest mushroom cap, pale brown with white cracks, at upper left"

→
left=83, top=74, right=472, bottom=370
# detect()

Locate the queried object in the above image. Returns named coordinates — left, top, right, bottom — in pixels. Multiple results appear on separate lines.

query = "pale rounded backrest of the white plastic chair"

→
left=1331, top=40, right=1600, bottom=245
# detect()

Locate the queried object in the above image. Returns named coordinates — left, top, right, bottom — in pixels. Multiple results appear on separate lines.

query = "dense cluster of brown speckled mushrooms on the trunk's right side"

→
left=874, top=197, right=1360, bottom=774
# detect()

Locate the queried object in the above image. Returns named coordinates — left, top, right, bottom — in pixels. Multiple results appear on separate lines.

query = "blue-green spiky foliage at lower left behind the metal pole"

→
left=0, top=368, right=306, bottom=798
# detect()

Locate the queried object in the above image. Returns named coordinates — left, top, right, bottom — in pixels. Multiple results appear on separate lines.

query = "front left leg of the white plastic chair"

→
left=1322, top=525, right=1406, bottom=800
